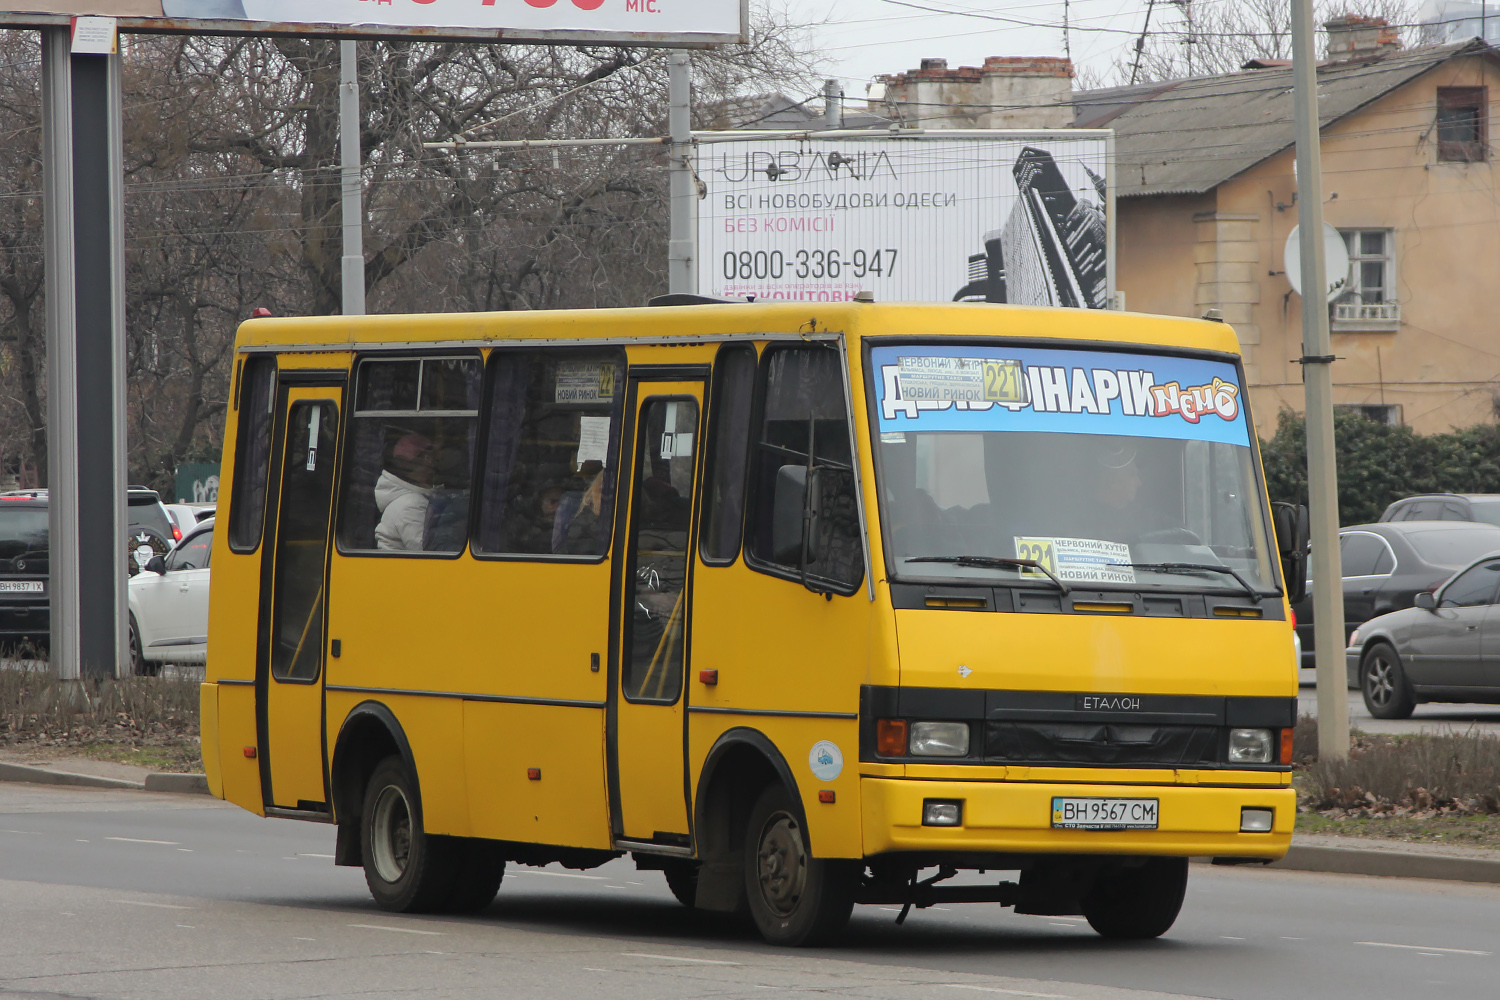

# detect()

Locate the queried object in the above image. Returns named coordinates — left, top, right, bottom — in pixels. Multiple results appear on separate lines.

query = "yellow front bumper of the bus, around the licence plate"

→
left=860, top=778, right=1296, bottom=859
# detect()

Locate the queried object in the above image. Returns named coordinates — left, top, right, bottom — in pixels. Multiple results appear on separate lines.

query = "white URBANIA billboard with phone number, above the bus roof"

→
left=695, top=130, right=1115, bottom=309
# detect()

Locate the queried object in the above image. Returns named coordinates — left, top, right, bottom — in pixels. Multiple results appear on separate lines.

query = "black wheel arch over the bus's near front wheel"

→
left=693, top=727, right=810, bottom=913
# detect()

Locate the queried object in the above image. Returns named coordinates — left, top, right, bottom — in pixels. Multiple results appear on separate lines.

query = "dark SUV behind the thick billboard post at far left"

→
left=0, top=486, right=173, bottom=643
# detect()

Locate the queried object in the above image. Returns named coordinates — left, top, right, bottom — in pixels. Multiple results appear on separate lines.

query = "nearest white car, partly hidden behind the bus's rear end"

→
left=129, top=519, right=213, bottom=675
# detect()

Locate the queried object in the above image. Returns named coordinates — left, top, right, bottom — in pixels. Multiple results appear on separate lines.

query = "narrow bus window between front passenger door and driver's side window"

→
left=702, top=343, right=756, bottom=565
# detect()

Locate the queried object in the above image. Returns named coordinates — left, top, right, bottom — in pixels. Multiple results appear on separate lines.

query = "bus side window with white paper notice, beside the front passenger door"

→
left=474, top=348, right=626, bottom=559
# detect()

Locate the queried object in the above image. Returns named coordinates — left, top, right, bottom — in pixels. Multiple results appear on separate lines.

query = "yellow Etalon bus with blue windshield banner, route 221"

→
left=203, top=297, right=1305, bottom=945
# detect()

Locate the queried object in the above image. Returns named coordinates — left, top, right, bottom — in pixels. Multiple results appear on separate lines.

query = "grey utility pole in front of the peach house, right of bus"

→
left=1292, top=0, right=1349, bottom=760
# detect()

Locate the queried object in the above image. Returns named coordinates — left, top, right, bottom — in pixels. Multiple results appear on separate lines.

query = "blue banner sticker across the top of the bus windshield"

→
left=870, top=345, right=1250, bottom=447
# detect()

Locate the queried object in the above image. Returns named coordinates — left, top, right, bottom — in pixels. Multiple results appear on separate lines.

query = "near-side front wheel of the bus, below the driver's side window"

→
left=744, top=784, right=860, bottom=948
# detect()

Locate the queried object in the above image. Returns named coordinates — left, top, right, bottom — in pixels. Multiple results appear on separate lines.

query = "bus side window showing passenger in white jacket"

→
left=339, top=355, right=482, bottom=555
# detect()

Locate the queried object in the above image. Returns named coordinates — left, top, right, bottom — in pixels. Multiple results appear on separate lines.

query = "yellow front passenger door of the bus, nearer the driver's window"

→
left=609, top=381, right=704, bottom=849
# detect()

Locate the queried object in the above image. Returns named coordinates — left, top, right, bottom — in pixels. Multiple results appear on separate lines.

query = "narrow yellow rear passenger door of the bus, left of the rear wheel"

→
left=255, top=382, right=344, bottom=811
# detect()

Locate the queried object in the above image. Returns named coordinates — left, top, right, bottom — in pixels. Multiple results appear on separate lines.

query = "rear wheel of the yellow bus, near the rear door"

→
left=362, top=757, right=456, bottom=913
